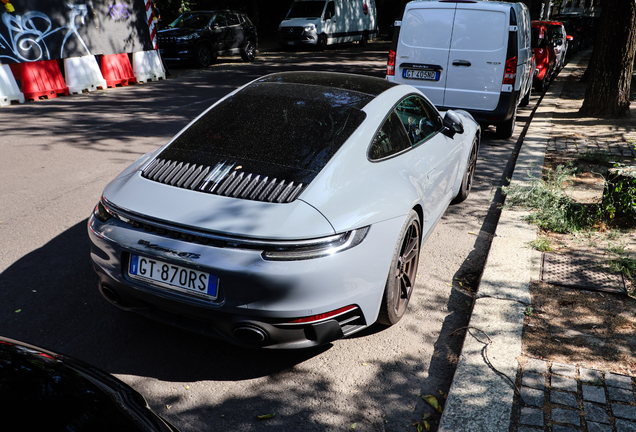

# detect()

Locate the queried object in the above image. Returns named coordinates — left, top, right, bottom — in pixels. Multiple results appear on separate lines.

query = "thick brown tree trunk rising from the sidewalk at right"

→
left=579, top=0, right=636, bottom=118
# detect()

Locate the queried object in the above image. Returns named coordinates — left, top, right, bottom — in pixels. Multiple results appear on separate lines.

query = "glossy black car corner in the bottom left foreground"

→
left=0, top=337, right=177, bottom=432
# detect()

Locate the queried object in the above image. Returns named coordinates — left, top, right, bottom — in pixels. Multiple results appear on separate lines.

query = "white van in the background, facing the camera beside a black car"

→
left=278, top=0, right=378, bottom=50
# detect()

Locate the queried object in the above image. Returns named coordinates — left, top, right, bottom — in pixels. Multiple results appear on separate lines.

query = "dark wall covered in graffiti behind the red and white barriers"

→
left=0, top=0, right=151, bottom=63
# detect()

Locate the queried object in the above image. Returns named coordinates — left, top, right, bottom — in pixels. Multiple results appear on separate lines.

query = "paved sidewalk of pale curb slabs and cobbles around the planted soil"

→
left=438, top=51, right=636, bottom=432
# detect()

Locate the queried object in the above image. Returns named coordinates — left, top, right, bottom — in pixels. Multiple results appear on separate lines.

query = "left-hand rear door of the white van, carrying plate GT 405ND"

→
left=395, top=2, right=456, bottom=106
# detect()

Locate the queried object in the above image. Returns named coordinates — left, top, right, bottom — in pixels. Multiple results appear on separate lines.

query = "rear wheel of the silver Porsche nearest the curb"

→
left=378, top=210, right=421, bottom=325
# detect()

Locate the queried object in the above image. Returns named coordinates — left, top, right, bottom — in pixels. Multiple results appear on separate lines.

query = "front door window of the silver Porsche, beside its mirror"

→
left=395, top=95, right=443, bottom=146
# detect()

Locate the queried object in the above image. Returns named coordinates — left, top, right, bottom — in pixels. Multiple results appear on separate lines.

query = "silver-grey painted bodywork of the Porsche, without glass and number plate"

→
left=88, top=71, right=479, bottom=347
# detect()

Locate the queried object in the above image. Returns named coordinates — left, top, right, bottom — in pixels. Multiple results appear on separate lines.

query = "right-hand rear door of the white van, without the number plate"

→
left=444, top=3, right=509, bottom=111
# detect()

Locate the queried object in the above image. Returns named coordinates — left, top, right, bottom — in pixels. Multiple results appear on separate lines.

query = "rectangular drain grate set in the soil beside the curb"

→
left=541, top=253, right=627, bottom=293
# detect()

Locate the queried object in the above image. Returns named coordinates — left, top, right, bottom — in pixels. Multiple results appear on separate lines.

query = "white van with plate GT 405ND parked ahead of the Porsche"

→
left=387, top=0, right=534, bottom=138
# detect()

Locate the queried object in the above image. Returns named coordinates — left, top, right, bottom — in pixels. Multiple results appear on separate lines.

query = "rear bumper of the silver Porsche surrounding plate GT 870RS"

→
left=88, top=216, right=401, bottom=349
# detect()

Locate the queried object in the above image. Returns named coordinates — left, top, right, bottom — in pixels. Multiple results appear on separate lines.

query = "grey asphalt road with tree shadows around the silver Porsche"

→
left=0, top=43, right=537, bottom=431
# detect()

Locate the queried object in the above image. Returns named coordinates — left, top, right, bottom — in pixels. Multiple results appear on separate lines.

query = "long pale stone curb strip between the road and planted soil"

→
left=438, top=54, right=582, bottom=432
